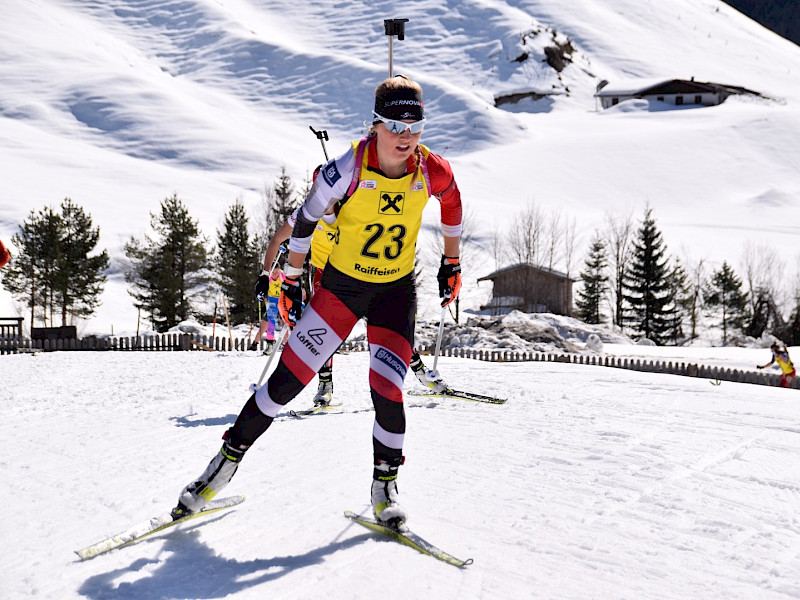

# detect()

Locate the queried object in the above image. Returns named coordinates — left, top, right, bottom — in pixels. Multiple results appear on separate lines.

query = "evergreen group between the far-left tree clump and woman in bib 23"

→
left=125, top=168, right=308, bottom=331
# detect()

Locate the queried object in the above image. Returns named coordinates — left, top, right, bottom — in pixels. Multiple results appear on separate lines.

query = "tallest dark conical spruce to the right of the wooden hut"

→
left=623, top=208, right=673, bottom=345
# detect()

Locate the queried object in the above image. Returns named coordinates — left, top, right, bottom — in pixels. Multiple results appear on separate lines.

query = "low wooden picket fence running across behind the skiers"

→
left=0, top=333, right=800, bottom=389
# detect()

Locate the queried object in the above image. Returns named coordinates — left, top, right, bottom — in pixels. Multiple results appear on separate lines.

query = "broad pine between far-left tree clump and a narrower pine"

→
left=125, top=194, right=209, bottom=331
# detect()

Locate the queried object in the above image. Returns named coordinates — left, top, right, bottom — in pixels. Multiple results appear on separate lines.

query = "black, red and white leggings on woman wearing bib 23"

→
left=229, top=264, right=417, bottom=463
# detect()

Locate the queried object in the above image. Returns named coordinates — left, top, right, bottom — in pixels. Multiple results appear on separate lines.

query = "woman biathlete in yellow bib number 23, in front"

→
left=173, top=76, right=461, bottom=522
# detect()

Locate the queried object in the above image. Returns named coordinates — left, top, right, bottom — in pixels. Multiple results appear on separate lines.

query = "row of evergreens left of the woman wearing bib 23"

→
left=0, top=168, right=310, bottom=332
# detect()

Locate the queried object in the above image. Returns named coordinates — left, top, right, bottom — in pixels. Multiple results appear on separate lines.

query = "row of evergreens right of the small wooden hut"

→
left=575, top=207, right=800, bottom=345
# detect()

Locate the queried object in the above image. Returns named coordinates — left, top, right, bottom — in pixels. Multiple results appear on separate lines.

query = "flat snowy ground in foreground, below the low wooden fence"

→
left=6, top=349, right=800, bottom=600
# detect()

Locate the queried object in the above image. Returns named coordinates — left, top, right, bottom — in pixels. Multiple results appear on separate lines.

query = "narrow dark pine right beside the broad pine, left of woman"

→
left=215, top=200, right=260, bottom=325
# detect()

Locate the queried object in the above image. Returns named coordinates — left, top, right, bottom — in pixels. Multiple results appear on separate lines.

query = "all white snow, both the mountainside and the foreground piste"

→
left=0, top=0, right=800, bottom=600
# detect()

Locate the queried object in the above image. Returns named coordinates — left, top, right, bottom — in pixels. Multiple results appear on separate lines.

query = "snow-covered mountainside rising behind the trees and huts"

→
left=0, top=0, right=800, bottom=333
